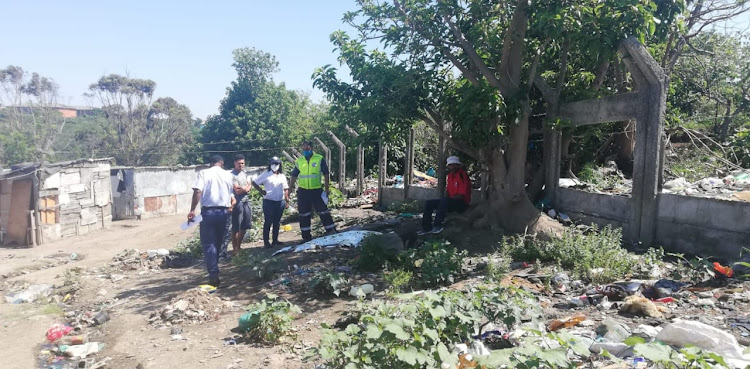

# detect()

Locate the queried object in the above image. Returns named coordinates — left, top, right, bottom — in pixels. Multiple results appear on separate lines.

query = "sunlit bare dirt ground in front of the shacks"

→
left=0, top=209, right=384, bottom=369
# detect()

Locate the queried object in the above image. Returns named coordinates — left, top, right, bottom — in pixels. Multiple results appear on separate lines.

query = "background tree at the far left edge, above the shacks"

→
left=0, top=65, right=66, bottom=164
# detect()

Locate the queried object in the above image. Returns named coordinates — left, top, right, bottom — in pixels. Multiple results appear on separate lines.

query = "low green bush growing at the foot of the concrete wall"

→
left=503, top=226, right=637, bottom=283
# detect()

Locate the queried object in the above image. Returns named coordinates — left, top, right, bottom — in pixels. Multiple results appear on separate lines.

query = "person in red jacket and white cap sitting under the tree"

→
left=421, top=156, right=471, bottom=234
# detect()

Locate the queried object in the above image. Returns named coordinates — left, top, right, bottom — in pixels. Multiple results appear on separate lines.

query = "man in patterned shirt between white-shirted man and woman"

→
left=231, top=154, right=253, bottom=255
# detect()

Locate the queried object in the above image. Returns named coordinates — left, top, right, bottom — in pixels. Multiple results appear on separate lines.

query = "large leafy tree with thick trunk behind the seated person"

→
left=316, top=0, right=682, bottom=232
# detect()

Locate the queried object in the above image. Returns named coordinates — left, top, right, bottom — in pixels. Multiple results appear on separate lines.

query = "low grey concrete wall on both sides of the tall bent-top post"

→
left=555, top=188, right=750, bottom=259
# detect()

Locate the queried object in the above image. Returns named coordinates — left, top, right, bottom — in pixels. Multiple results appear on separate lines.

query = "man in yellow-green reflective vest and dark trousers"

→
left=289, top=141, right=336, bottom=241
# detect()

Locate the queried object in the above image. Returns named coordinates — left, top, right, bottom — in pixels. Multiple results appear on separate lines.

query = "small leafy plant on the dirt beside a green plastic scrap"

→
left=246, top=294, right=302, bottom=343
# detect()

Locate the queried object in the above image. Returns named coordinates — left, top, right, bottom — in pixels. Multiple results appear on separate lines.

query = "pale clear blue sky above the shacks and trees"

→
left=0, top=0, right=356, bottom=118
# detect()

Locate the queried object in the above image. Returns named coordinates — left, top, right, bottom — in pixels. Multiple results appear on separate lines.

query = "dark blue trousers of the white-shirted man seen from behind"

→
left=200, top=208, right=229, bottom=279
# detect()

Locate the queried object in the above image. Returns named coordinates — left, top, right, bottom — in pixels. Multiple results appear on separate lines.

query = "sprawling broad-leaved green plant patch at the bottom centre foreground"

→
left=308, top=289, right=541, bottom=369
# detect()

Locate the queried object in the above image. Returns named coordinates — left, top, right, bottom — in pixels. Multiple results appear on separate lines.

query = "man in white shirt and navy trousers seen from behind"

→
left=188, top=155, right=235, bottom=287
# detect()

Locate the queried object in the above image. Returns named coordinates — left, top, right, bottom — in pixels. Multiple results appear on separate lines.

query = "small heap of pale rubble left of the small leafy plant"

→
left=148, top=288, right=237, bottom=325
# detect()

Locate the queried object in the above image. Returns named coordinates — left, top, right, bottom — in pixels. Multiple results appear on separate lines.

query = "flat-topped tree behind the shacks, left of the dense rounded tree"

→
left=89, top=74, right=194, bottom=165
